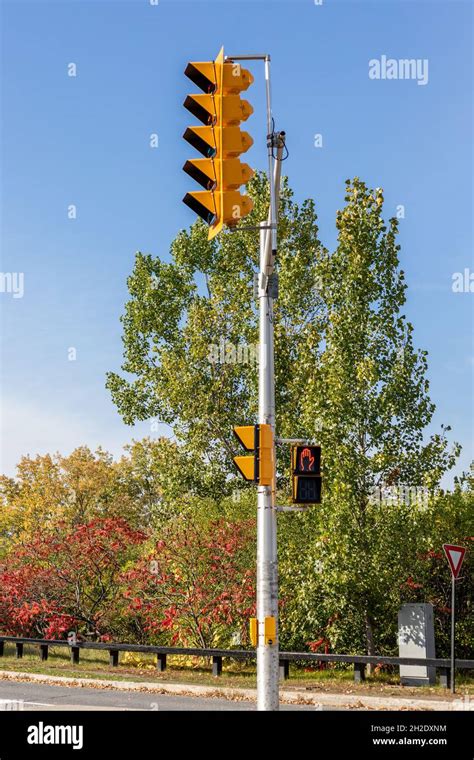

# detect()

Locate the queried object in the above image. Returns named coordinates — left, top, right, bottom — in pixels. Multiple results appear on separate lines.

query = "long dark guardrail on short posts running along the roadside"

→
left=0, top=636, right=474, bottom=688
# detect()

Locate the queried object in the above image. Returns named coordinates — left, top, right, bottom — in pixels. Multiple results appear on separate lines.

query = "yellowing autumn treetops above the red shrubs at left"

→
left=0, top=437, right=222, bottom=556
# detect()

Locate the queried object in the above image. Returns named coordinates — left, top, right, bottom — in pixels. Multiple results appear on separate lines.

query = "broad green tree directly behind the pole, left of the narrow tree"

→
left=107, top=175, right=322, bottom=496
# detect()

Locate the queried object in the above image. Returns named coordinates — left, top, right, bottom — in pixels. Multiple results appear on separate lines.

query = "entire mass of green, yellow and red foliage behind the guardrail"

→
left=0, top=174, right=466, bottom=655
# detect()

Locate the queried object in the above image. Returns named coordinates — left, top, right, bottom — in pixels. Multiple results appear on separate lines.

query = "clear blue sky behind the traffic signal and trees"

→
left=0, top=0, right=474, bottom=484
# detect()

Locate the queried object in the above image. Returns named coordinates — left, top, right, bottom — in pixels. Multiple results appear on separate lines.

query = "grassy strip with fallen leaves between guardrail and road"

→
left=0, top=644, right=474, bottom=699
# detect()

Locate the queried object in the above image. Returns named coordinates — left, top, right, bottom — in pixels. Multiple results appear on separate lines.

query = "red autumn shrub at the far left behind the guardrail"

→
left=0, top=518, right=146, bottom=638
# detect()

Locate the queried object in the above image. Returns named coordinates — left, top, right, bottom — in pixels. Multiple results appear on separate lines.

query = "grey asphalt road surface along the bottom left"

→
left=0, top=681, right=315, bottom=711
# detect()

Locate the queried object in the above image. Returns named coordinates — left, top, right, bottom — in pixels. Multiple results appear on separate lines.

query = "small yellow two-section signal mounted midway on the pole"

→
left=234, top=425, right=275, bottom=486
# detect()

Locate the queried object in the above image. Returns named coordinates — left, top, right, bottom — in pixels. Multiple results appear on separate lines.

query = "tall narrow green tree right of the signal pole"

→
left=305, top=178, right=459, bottom=653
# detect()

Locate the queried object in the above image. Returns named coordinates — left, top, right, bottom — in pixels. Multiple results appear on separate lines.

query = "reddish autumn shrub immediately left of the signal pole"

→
left=123, top=518, right=255, bottom=647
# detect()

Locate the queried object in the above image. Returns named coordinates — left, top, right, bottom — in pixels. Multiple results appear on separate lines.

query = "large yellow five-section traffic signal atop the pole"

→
left=183, top=48, right=254, bottom=240
